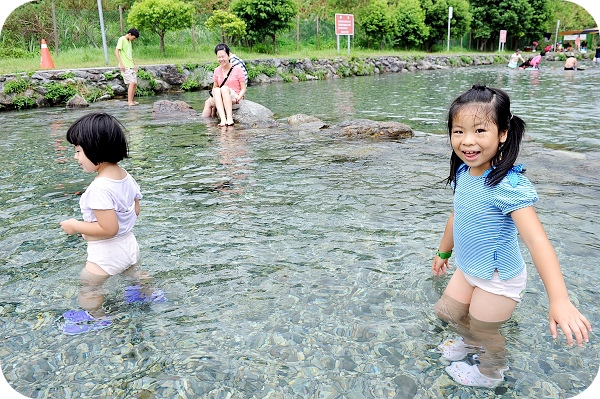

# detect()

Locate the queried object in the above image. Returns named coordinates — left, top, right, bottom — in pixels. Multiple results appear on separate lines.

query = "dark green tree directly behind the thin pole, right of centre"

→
left=421, top=0, right=472, bottom=51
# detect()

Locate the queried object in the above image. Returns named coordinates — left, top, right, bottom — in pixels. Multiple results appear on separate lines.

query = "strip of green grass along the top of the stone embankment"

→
left=0, top=44, right=496, bottom=75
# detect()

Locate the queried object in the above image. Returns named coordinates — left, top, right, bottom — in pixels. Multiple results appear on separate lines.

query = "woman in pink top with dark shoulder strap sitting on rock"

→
left=202, top=43, right=246, bottom=126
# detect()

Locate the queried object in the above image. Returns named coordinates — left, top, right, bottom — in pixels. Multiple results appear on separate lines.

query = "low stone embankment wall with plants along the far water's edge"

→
left=0, top=54, right=508, bottom=111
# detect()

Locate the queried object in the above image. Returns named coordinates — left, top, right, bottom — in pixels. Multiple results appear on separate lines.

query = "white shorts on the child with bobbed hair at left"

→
left=87, top=231, right=140, bottom=276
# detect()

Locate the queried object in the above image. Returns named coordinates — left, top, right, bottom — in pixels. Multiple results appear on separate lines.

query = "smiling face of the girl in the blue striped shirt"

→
left=450, top=104, right=507, bottom=176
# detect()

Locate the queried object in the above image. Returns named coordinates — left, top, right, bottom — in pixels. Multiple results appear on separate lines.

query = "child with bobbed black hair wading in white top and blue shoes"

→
left=60, top=113, right=165, bottom=335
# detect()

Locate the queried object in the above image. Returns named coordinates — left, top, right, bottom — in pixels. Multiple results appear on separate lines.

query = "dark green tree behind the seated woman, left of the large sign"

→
left=231, top=0, right=298, bottom=54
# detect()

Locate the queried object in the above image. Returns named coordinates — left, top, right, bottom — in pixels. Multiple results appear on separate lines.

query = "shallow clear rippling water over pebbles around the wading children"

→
left=0, top=64, right=600, bottom=398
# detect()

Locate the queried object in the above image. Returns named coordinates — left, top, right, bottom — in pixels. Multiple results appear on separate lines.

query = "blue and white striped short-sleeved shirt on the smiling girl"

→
left=454, top=164, right=538, bottom=280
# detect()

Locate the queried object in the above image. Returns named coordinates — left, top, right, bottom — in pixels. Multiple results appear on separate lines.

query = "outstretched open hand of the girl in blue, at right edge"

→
left=549, top=299, right=592, bottom=346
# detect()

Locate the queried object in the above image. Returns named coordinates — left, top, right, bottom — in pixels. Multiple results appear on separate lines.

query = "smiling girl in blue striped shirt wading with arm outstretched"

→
left=432, top=85, right=592, bottom=388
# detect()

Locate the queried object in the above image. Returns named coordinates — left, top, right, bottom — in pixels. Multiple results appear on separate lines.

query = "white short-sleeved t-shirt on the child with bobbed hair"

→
left=79, top=173, right=142, bottom=236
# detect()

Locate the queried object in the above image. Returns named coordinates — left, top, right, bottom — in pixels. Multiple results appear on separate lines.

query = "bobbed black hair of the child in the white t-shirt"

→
left=67, top=112, right=129, bottom=165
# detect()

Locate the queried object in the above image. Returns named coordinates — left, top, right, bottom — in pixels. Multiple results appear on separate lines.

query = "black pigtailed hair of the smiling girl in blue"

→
left=446, top=85, right=525, bottom=189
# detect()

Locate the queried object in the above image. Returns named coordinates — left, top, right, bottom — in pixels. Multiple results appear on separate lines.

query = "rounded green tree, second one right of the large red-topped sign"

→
left=392, top=0, right=429, bottom=47
